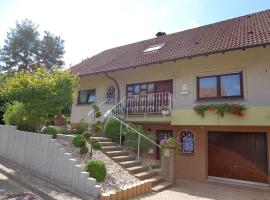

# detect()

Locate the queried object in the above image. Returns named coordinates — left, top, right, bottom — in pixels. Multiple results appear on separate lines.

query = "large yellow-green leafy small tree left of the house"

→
left=0, top=69, right=77, bottom=131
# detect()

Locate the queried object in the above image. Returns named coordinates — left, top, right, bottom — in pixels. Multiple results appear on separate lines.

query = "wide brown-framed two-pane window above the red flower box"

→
left=197, top=72, right=244, bottom=100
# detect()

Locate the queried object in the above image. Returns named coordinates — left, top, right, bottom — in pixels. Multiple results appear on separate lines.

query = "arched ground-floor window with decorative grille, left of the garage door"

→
left=179, top=130, right=195, bottom=154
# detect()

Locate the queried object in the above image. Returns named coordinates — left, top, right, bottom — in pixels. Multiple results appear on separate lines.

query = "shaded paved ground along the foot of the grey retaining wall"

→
left=0, top=158, right=84, bottom=200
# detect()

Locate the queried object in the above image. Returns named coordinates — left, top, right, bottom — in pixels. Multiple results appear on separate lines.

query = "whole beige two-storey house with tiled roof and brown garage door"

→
left=71, top=10, right=270, bottom=185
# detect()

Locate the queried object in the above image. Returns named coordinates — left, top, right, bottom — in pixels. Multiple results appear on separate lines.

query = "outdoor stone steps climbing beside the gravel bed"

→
left=95, top=136, right=172, bottom=192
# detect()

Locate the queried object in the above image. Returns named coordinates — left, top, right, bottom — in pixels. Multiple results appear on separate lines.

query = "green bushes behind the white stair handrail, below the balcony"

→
left=124, top=123, right=155, bottom=151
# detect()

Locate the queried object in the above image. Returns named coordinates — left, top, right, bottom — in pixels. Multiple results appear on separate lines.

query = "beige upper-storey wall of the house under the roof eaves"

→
left=71, top=46, right=270, bottom=125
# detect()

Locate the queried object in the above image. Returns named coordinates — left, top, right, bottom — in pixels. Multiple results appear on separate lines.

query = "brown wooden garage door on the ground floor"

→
left=208, top=132, right=268, bottom=183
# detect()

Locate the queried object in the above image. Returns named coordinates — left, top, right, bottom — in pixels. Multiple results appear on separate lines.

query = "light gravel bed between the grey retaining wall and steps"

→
left=57, top=135, right=140, bottom=192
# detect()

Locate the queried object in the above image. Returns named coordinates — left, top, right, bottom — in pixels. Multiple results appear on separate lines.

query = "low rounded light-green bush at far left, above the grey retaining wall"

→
left=4, top=102, right=40, bottom=132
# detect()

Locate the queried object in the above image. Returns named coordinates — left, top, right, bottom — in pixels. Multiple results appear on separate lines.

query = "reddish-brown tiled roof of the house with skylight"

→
left=70, top=10, right=270, bottom=75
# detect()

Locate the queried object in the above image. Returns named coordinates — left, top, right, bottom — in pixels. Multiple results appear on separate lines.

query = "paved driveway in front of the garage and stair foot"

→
left=139, top=181, right=270, bottom=200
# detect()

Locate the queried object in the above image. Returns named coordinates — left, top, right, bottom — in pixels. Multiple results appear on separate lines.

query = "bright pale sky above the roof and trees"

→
left=0, top=0, right=270, bottom=67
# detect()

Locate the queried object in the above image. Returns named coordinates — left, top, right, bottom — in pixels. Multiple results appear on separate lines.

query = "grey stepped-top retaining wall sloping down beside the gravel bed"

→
left=0, top=126, right=101, bottom=198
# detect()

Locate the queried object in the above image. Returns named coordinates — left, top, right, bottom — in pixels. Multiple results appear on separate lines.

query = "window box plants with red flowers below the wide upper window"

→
left=194, top=103, right=247, bottom=117
